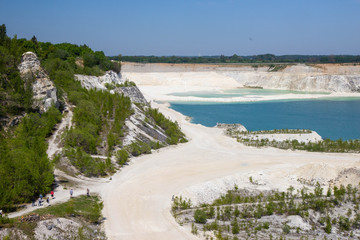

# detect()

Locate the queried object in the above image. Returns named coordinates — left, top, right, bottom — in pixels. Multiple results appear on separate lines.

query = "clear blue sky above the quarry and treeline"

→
left=0, top=0, right=360, bottom=56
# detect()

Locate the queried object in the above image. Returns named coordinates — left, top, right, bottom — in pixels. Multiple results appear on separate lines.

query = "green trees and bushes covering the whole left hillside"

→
left=0, top=24, right=184, bottom=212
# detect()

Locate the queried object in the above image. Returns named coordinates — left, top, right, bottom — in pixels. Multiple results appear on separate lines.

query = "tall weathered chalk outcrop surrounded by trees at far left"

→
left=18, top=52, right=59, bottom=112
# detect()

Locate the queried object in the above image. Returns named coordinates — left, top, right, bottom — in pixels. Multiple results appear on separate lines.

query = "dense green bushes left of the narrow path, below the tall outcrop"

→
left=0, top=107, right=61, bottom=210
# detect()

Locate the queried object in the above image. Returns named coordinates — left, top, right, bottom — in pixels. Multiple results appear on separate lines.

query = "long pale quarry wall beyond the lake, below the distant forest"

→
left=122, top=62, right=360, bottom=93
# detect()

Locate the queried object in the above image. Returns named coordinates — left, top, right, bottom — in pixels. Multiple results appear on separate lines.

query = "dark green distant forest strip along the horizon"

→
left=109, top=54, right=360, bottom=63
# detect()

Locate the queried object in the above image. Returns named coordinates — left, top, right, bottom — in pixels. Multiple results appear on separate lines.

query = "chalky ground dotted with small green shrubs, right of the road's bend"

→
left=173, top=183, right=360, bottom=239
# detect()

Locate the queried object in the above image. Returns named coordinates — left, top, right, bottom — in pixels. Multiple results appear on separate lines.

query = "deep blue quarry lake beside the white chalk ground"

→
left=171, top=96, right=360, bottom=140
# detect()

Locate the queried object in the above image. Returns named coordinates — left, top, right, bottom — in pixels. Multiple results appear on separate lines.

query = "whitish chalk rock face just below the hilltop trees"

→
left=75, top=71, right=124, bottom=90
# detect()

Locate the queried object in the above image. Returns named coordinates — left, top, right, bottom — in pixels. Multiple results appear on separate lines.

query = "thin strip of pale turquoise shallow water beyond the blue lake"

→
left=169, top=88, right=329, bottom=98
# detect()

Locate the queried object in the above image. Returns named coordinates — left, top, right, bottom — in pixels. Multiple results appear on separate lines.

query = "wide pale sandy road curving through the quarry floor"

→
left=102, top=102, right=359, bottom=239
